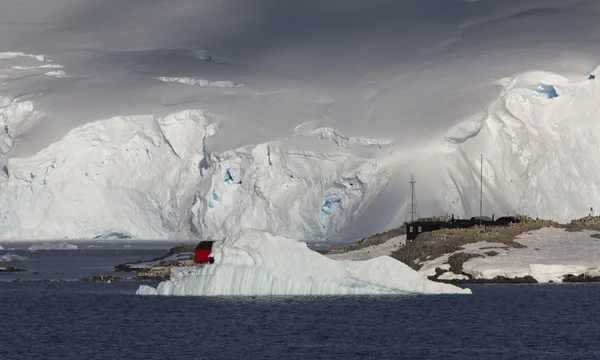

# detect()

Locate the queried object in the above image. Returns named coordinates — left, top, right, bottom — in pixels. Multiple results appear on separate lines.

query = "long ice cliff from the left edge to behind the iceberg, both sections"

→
left=0, top=93, right=390, bottom=240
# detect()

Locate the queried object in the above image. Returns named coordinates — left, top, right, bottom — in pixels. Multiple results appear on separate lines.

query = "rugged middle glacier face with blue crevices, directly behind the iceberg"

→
left=191, top=139, right=388, bottom=240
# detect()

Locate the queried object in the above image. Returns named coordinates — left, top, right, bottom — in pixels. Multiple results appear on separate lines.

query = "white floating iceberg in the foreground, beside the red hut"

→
left=137, top=229, right=470, bottom=296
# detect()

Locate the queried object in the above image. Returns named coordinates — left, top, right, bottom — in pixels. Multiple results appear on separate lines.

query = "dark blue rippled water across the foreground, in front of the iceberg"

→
left=0, top=282, right=600, bottom=360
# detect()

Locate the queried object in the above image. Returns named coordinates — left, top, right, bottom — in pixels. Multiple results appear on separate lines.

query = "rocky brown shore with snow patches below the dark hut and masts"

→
left=329, top=216, right=600, bottom=284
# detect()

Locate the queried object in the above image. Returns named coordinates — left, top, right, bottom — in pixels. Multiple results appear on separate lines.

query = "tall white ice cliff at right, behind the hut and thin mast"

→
left=439, top=69, right=600, bottom=222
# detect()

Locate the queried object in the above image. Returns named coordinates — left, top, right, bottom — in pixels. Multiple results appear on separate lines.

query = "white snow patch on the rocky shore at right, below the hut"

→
left=419, top=228, right=600, bottom=283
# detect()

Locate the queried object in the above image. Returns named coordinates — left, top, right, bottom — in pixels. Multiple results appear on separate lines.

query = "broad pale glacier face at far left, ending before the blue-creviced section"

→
left=0, top=111, right=214, bottom=239
